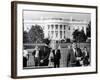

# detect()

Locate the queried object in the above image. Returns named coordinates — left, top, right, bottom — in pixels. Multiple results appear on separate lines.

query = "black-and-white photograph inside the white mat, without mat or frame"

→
left=23, top=10, right=91, bottom=69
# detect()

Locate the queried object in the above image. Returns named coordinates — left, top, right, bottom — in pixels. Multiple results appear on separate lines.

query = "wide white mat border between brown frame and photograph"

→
left=17, top=4, right=96, bottom=76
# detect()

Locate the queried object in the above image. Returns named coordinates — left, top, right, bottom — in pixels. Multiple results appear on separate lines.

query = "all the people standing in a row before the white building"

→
left=23, top=43, right=90, bottom=68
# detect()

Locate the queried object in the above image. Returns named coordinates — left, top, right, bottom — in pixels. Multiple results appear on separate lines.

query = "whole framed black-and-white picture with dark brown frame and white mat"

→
left=11, top=2, right=97, bottom=78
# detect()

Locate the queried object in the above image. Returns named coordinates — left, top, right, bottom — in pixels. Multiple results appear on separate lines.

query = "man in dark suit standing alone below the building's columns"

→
left=52, top=47, right=61, bottom=68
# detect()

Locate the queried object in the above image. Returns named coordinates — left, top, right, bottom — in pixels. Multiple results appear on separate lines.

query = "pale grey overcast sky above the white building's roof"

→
left=23, top=11, right=91, bottom=21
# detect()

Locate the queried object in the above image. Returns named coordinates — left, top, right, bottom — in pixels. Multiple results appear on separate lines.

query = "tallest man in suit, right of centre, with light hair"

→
left=67, top=43, right=82, bottom=67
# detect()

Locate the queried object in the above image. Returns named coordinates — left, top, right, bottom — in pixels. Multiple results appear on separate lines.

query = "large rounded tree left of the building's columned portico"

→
left=28, top=25, right=44, bottom=43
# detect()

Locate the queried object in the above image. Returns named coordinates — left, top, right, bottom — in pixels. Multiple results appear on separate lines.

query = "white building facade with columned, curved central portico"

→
left=24, top=18, right=89, bottom=41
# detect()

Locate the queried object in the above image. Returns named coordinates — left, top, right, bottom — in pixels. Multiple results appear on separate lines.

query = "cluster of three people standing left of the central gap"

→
left=32, top=45, right=61, bottom=68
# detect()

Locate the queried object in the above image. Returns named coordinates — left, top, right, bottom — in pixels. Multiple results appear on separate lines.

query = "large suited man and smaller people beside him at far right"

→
left=67, top=43, right=90, bottom=67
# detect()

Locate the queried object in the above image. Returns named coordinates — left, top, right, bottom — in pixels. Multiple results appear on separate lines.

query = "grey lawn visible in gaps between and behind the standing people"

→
left=24, top=43, right=91, bottom=67
